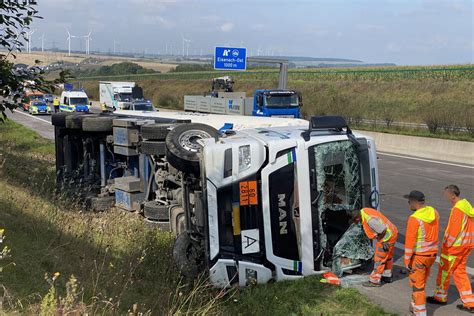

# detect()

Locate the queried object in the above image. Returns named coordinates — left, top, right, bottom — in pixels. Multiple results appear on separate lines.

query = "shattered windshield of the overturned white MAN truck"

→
left=310, top=140, right=371, bottom=270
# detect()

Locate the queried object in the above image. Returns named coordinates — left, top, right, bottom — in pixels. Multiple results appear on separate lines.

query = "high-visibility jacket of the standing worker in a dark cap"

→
left=405, top=206, right=439, bottom=266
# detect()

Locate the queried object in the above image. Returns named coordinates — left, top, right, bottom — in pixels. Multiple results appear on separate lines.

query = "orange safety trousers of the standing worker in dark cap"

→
left=409, top=254, right=436, bottom=316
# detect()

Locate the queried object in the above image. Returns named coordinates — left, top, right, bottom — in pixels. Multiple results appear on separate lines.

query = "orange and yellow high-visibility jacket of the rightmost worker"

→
left=442, top=199, right=474, bottom=255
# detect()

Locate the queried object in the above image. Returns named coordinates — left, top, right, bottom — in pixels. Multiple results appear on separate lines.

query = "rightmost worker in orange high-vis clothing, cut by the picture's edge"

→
left=427, top=184, right=474, bottom=313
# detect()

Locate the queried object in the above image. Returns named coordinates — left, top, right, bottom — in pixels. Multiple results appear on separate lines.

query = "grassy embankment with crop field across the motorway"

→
left=78, top=65, right=474, bottom=141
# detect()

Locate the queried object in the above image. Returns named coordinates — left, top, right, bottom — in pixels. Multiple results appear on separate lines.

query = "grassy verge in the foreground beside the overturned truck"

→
left=0, top=122, right=383, bottom=315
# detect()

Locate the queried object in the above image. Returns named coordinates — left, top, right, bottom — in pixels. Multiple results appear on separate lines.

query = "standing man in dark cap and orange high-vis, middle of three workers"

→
left=405, top=191, right=439, bottom=316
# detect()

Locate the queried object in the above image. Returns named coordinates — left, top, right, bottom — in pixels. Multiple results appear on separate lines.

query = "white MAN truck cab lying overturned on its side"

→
left=196, top=117, right=379, bottom=287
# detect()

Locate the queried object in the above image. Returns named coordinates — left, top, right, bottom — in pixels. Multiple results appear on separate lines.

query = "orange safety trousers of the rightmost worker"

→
left=435, top=248, right=474, bottom=308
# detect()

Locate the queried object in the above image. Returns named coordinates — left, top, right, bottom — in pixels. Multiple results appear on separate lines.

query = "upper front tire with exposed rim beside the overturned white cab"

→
left=166, top=123, right=219, bottom=174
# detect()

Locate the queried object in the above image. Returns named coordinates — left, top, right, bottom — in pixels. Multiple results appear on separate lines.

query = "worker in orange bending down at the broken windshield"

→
left=354, top=208, right=398, bottom=287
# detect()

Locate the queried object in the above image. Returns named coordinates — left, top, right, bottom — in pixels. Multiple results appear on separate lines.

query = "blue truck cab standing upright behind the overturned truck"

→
left=252, top=90, right=303, bottom=118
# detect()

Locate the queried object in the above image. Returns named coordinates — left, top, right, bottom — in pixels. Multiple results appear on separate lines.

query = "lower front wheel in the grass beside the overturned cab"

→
left=173, top=232, right=203, bottom=280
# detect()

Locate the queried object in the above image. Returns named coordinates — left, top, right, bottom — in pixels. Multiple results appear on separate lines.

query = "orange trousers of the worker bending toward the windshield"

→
left=369, top=228, right=398, bottom=283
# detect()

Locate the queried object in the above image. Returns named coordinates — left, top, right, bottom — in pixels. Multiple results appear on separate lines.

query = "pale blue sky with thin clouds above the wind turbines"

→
left=33, top=0, right=474, bottom=65
